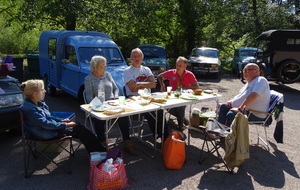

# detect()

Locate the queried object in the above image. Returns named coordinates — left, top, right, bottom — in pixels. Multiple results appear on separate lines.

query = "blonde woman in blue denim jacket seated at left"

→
left=20, top=80, right=106, bottom=152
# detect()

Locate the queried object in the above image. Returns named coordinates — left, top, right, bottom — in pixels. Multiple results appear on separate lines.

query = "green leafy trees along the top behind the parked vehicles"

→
left=0, top=0, right=300, bottom=72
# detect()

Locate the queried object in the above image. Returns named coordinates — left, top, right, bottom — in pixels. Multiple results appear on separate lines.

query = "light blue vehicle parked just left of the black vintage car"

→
left=231, top=47, right=262, bottom=77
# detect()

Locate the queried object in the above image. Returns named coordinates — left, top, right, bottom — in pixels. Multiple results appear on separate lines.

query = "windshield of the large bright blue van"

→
left=78, top=47, right=124, bottom=65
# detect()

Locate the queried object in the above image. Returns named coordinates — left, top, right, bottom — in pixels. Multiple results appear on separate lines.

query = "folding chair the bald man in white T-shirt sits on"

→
left=248, top=90, right=283, bottom=150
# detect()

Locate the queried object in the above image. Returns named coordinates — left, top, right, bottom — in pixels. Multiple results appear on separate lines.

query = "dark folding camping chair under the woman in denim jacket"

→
left=20, top=110, right=75, bottom=178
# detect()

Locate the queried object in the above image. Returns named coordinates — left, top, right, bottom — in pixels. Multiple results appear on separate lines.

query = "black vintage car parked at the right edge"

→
left=257, top=30, right=300, bottom=84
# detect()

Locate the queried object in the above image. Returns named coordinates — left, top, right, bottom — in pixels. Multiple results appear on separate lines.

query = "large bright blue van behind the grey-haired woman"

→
left=39, top=30, right=127, bottom=100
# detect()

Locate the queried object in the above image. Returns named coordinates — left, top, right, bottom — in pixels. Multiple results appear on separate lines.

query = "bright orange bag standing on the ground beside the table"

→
left=163, top=130, right=186, bottom=170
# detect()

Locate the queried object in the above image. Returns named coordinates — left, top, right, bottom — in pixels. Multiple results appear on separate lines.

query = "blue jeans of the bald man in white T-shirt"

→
left=218, top=103, right=264, bottom=127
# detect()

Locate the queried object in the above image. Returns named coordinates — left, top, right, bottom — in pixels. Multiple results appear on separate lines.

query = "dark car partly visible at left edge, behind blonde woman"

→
left=0, top=76, right=24, bottom=132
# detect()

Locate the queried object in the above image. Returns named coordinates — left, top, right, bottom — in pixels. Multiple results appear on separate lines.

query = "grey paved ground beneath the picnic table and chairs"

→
left=0, top=75, right=300, bottom=190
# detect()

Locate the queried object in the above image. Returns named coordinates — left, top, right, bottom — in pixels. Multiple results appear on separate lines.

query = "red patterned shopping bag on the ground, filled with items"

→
left=87, top=149, right=130, bottom=190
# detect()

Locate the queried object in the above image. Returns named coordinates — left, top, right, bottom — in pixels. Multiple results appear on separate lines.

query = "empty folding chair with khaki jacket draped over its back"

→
left=199, top=113, right=249, bottom=173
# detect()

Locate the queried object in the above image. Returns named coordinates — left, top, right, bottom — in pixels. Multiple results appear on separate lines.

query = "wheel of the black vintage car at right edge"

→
left=277, top=60, right=300, bottom=84
